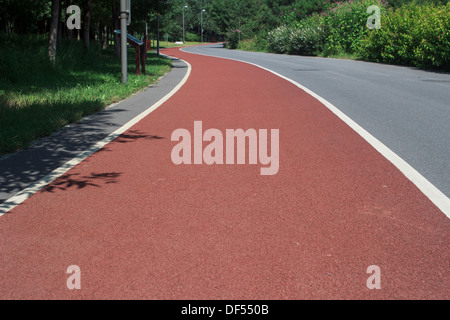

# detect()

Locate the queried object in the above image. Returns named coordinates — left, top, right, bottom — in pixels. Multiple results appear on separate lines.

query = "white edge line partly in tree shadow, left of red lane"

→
left=0, top=59, right=192, bottom=216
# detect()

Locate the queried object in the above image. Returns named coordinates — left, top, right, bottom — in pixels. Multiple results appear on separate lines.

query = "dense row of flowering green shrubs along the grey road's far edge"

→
left=262, top=0, right=450, bottom=70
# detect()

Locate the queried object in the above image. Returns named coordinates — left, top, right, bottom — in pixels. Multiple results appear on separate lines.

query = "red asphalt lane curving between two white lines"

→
left=0, top=49, right=450, bottom=300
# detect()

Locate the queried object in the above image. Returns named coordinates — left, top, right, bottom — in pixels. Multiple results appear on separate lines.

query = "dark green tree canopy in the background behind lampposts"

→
left=0, top=0, right=448, bottom=47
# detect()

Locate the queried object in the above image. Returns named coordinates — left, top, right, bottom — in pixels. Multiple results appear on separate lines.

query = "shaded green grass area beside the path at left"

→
left=0, top=36, right=172, bottom=155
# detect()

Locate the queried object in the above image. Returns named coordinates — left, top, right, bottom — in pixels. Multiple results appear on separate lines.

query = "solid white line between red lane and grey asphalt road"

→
left=180, top=49, right=450, bottom=218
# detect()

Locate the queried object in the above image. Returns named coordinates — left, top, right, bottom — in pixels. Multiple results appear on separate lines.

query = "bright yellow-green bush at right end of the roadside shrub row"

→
left=359, top=3, right=450, bottom=70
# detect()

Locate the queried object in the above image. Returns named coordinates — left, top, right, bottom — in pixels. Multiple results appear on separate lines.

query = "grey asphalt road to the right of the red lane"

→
left=183, top=44, right=450, bottom=196
